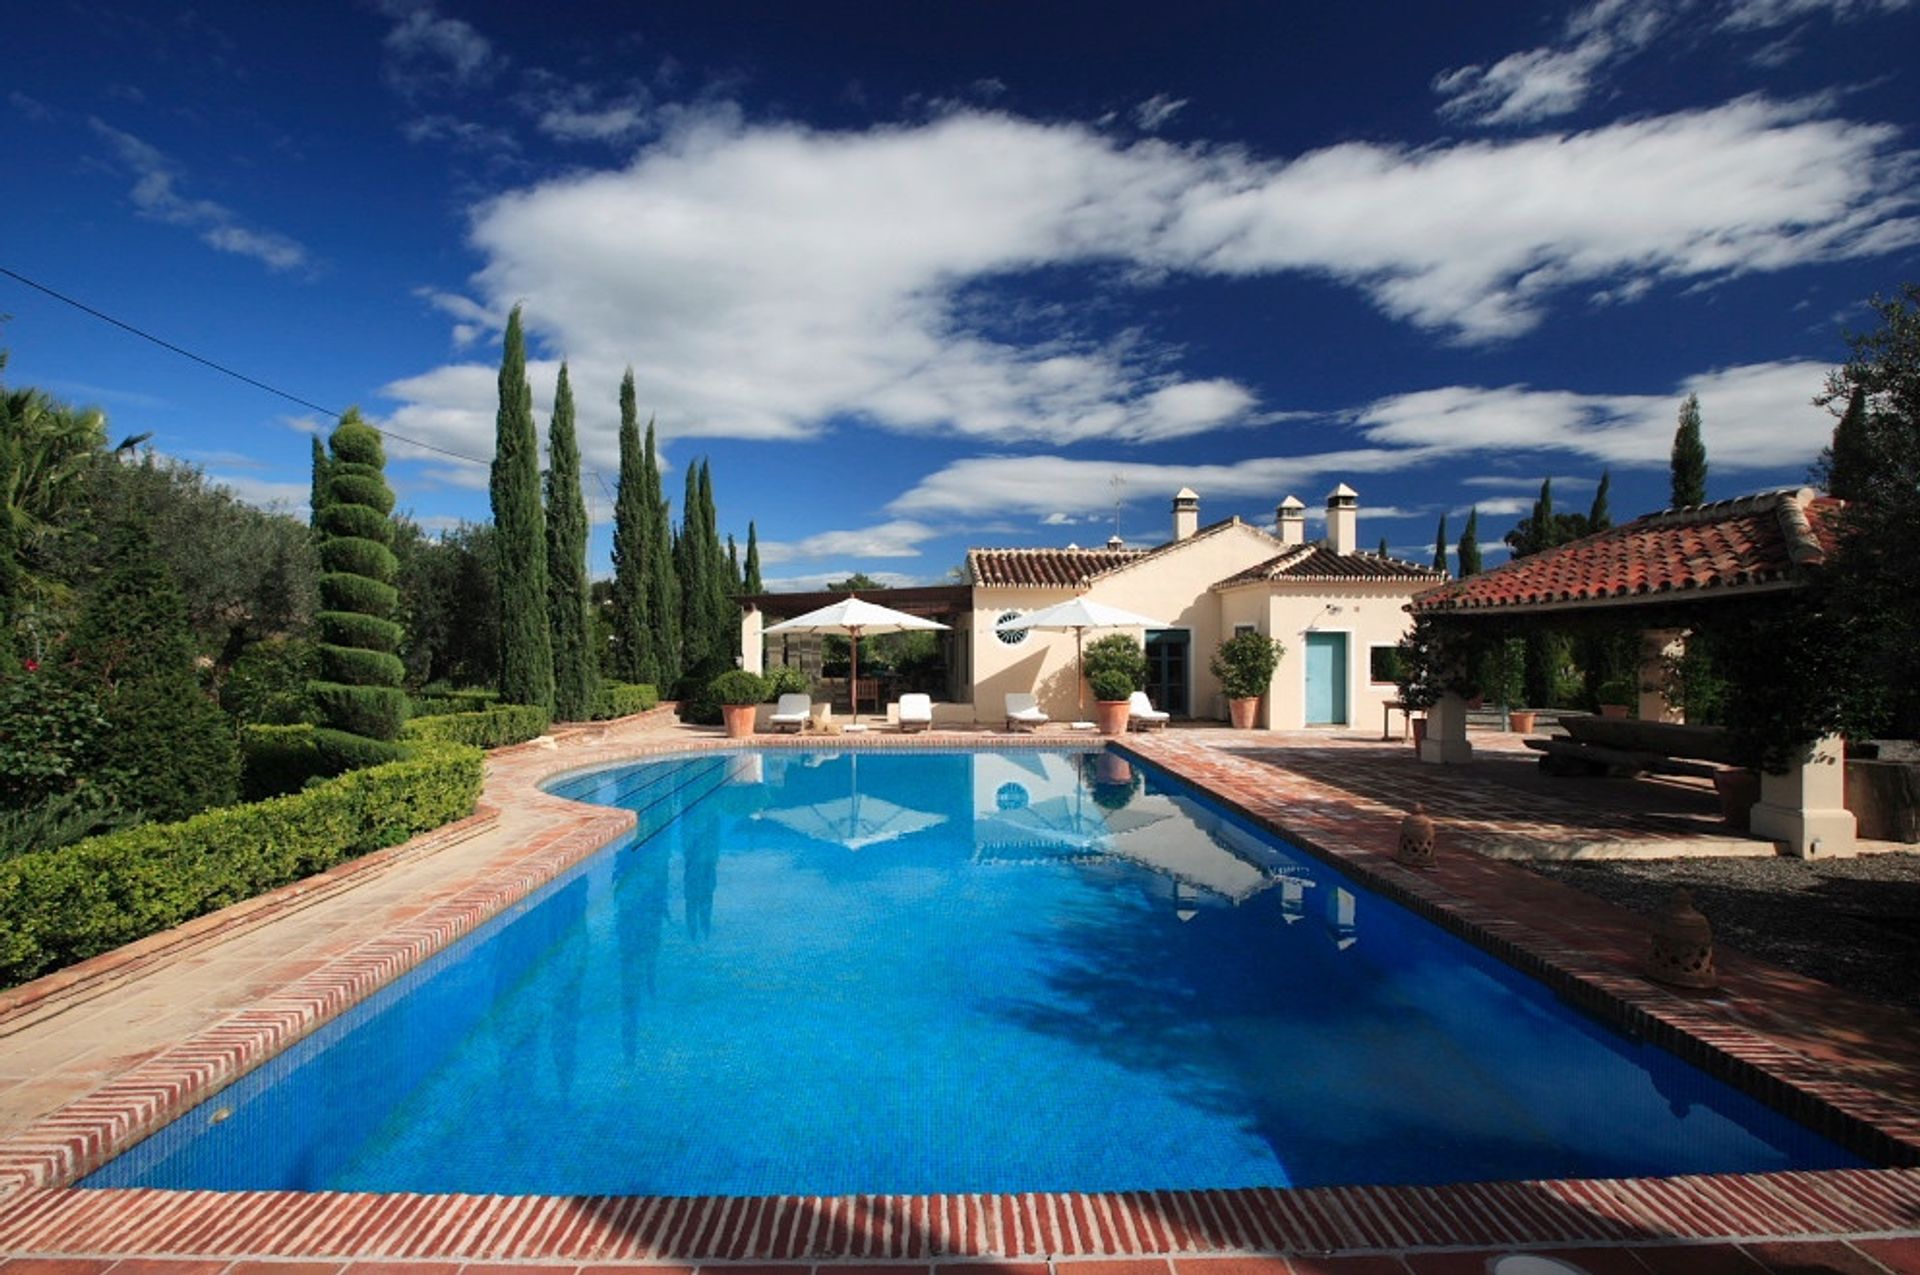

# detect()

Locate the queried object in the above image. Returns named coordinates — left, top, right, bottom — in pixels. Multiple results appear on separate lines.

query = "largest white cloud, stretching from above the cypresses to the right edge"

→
left=390, top=98, right=1920, bottom=458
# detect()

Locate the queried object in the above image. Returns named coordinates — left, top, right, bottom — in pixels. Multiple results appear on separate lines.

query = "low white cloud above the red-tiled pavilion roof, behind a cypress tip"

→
left=1359, top=361, right=1834, bottom=470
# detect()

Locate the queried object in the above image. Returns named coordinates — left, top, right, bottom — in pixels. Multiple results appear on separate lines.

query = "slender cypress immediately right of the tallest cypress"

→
left=547, top=363, right=599, bottom=722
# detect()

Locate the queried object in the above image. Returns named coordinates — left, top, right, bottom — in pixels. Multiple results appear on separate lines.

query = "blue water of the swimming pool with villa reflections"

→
left=83, top=751, right=1859, bottom=1194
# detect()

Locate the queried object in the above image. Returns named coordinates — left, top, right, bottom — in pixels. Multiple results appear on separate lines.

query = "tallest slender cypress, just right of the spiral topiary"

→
left=488, top=305, right=553, bottom=712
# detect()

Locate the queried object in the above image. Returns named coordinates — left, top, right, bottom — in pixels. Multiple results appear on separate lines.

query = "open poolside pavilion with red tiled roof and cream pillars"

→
left=1409, top=488, right=1855, bottom=854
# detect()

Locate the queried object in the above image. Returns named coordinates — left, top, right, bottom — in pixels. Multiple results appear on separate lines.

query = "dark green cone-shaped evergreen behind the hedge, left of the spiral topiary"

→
left=69, top=518, right=240, bottom=822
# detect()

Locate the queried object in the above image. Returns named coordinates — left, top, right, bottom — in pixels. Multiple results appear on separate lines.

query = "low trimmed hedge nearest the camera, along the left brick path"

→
left=0, top=743, right=480, bottom=987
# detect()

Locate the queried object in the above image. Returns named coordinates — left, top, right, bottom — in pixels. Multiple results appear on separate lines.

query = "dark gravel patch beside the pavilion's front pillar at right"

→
left=1526, top=853, right=1920, bottom=1010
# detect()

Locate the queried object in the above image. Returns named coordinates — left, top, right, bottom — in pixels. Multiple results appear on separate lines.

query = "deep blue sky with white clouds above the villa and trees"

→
left=0, top=0, right=1920, bottom=588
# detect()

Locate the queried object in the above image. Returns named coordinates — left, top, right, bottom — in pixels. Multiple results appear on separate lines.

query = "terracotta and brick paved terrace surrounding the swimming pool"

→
left=0, top=714, right=1920, bottom=1275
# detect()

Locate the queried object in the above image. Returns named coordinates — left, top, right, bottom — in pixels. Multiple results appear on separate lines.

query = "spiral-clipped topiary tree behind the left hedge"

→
left=311, top=409, right=407, bottom=741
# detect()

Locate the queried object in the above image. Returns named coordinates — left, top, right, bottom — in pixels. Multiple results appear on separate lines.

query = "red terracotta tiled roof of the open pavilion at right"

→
left=1409, top=488, right=1845, bottom=614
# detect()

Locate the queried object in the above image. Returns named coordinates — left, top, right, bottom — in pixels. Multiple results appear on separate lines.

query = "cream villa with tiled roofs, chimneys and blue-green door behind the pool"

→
left=741, top=484, right=1446, bottom=730
